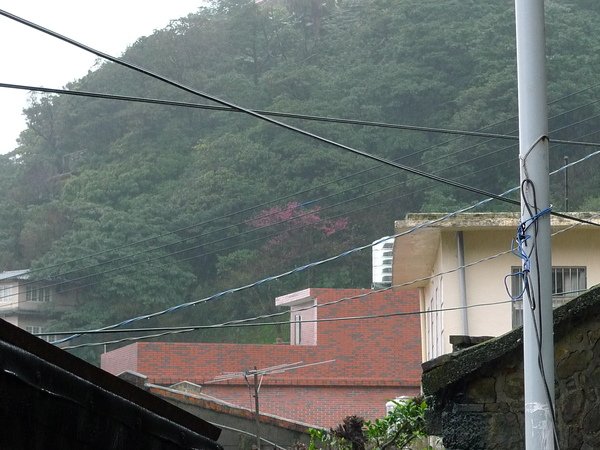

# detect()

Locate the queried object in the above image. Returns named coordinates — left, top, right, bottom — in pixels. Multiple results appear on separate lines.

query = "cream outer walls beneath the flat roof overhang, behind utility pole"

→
left=423, top=228, right=600, bottom=359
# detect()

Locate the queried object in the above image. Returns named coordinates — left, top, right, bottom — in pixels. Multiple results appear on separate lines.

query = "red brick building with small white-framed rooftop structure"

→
left=102, top=289, right=421, bottom=427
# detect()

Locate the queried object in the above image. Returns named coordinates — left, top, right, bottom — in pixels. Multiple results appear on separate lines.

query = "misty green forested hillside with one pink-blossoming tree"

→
left=0, top=0, right=600, bottom=352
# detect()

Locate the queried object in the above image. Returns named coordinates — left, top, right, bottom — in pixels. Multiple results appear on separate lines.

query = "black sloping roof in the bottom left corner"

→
left=0, top=320, right=220, bottom=450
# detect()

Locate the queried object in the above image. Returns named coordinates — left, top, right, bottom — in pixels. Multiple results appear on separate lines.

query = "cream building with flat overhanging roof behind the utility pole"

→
left=393, top=213, right=600, bottom=360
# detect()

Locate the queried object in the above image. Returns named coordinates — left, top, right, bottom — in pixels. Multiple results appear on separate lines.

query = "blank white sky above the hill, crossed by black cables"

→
left=0, top=0, right=203, bottom=153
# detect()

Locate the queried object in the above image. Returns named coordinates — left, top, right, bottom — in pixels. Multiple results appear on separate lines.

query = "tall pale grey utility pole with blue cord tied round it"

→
left=515, top=0, right=555, bottom=450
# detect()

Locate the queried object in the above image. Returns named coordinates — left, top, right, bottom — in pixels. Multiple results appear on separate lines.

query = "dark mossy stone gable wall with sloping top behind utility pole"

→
left=423, top=288, right=600, bottom=450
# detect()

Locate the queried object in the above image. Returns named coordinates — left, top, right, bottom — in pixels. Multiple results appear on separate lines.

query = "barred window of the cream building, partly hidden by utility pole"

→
left=511, top=267, right=587, bottom=328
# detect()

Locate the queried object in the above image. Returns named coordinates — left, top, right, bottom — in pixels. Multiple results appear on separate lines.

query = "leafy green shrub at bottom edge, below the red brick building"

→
left=309, top=397, right=427, bottom=450
